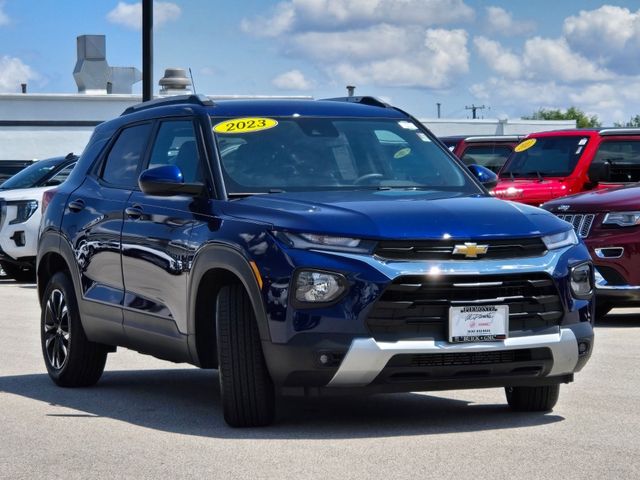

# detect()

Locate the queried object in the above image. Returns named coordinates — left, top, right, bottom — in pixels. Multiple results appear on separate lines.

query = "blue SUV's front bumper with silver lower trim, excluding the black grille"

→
left=263, top=245, right=593, bottom=394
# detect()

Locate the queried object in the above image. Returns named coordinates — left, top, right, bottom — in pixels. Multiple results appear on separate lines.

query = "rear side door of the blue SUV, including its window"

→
left=62, top=122, right=152, bottom=344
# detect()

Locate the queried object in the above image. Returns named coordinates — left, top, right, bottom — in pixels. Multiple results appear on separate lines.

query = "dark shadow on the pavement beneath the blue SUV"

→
left=0, top=369, right=564, bottom=440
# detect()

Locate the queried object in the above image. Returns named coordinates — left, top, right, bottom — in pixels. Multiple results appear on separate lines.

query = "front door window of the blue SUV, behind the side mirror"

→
left=148, top=120, right=203, bottom=183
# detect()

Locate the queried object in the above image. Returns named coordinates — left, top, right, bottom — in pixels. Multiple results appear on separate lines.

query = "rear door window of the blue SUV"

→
left=102, top=123, right=151, bottom=188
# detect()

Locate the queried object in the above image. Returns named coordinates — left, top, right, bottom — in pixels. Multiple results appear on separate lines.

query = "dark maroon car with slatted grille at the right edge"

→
left=542, top=184, right=640, bottom=318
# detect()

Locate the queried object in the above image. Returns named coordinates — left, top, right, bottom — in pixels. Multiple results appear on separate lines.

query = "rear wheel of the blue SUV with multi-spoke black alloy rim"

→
left=40, top=272, right=107, bottom=387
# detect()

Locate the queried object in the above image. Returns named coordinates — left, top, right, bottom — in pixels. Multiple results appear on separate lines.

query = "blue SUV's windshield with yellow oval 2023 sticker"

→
left=212, top=117, right=482, bottom=194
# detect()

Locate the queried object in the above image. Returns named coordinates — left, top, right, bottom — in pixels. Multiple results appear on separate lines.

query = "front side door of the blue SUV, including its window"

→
left=122, top=118, right=206, bottom=360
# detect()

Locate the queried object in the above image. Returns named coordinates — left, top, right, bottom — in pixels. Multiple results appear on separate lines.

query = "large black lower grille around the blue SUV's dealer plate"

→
left=367, top=273, right=563, bottom=340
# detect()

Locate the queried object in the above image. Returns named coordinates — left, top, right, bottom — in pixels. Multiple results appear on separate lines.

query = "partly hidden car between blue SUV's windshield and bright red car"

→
left=441, top=135, right=523, bottom=173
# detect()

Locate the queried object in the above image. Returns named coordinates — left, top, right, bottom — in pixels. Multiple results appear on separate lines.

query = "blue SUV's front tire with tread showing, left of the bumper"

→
left=216, top=285, right=275, bottom=427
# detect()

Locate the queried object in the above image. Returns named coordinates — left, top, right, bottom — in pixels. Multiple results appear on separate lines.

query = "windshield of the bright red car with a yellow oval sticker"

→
left=500, top=135, right=588, bottom=178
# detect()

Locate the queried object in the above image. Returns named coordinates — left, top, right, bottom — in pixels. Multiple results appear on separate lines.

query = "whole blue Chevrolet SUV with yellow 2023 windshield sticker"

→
left=37, top=96, right=594, bottom=426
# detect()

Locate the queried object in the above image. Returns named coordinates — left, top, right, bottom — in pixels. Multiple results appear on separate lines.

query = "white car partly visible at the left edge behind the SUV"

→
left=0, top=153, right=77, bottom=281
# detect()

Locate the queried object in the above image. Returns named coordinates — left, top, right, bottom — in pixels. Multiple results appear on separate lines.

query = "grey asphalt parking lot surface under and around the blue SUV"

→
left=0, top=279, right=640, bottom=479
